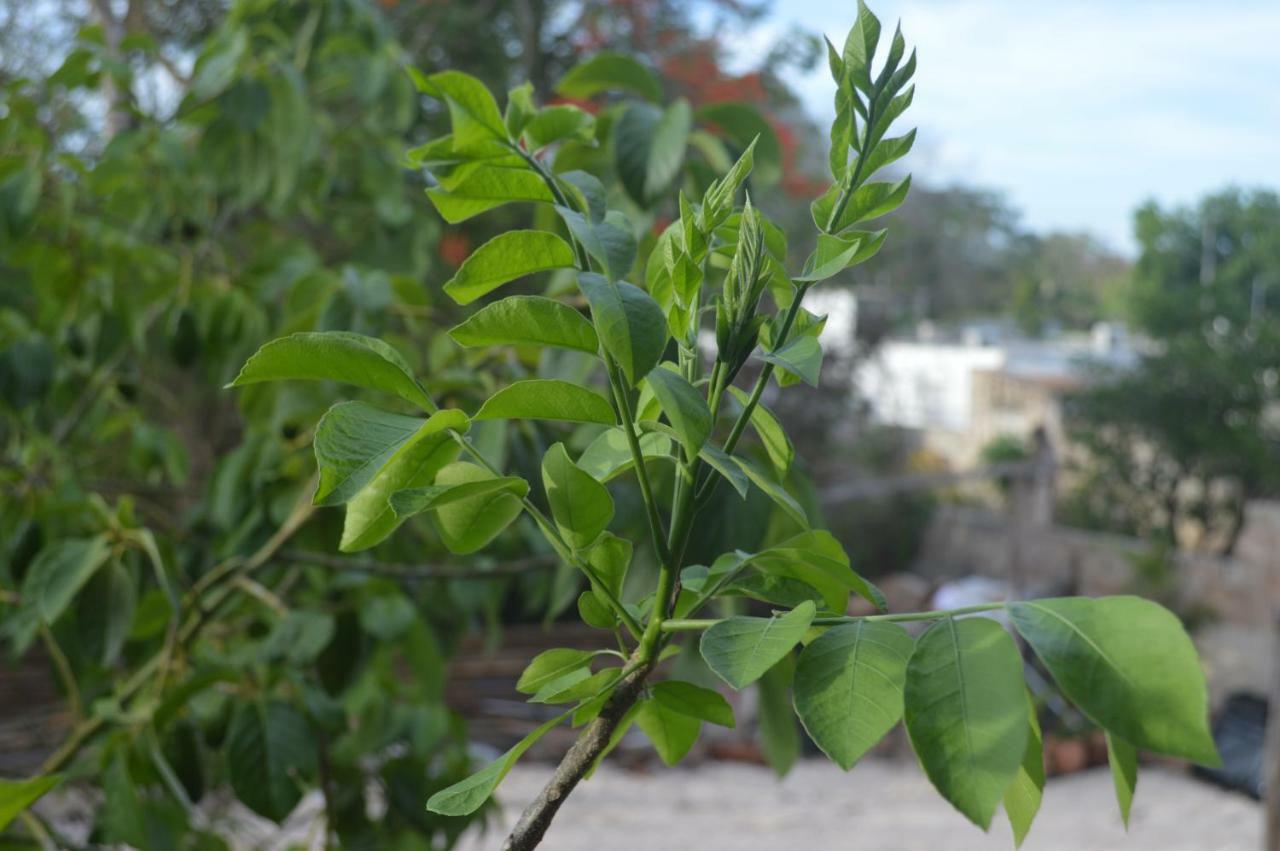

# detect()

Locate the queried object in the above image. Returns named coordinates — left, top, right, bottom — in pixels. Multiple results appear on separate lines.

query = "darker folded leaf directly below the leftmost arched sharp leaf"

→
left=314, top=402, right=428, bottom=505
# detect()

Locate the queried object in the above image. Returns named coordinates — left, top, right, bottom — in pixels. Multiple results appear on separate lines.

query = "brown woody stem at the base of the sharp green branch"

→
left=502, top=665, right=652, bottom=851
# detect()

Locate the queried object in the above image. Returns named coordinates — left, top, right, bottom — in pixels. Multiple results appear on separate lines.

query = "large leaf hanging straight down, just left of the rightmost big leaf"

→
left=904, top=618, right=1028, bottom=831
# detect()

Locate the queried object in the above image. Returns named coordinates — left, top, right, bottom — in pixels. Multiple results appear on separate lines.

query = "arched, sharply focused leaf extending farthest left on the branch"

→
left=236, top=331, right=435, bottom=411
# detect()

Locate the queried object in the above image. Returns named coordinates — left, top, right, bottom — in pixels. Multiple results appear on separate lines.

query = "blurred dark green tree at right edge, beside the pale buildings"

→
left=1068, top=189, right=1280, bottom=549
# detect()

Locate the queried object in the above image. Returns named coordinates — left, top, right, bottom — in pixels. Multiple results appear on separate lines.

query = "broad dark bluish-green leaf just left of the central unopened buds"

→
left=577, top=273, right=667, bottom=383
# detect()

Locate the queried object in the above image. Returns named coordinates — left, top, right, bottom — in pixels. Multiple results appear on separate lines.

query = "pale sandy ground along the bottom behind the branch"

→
left=462, top=760, right=1262, bottom=851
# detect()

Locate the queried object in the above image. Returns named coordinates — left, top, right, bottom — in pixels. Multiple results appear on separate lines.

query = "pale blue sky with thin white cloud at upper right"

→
left=737, top=0, right=1280, bottom=255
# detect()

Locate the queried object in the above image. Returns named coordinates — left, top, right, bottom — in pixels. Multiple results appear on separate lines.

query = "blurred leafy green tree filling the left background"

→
left=0, top=0, right=808, bottom=848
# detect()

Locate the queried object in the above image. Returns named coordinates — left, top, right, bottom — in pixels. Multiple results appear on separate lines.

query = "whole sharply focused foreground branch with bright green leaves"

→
left=217, top=5, right=1217, bottom=850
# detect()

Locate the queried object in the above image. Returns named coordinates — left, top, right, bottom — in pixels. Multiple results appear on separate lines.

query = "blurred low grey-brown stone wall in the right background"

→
left=914, top=502, right=1280, bottom=701
